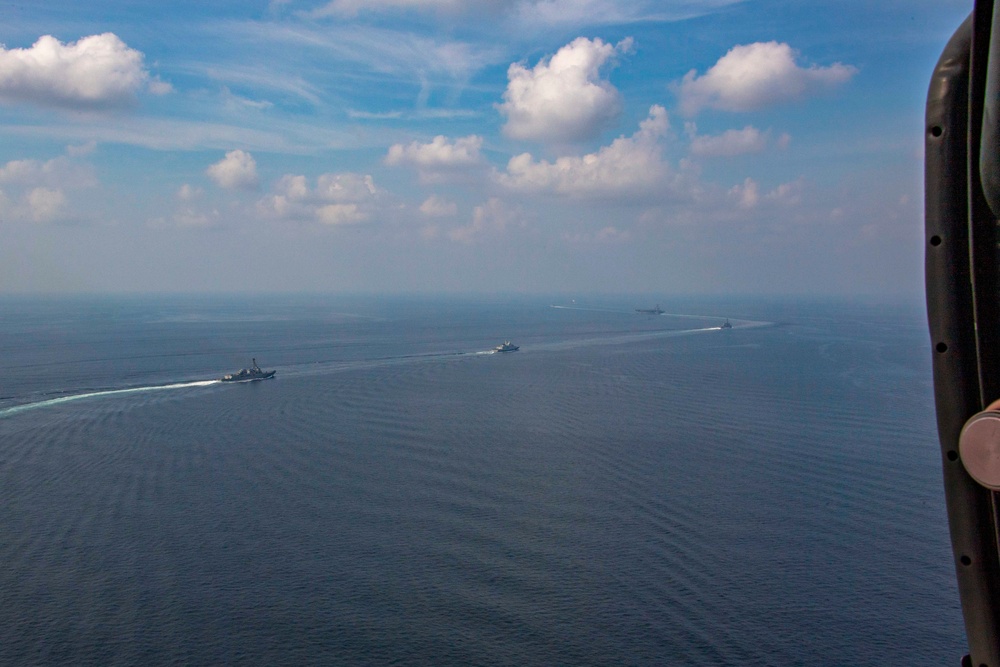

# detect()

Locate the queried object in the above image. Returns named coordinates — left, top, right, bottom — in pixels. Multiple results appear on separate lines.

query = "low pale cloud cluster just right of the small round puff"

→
left=257, top=173, right=381, bottom=225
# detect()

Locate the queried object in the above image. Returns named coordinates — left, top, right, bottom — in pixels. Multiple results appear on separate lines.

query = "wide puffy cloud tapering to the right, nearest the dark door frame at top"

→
left=678, top=42, right=858, bottom=115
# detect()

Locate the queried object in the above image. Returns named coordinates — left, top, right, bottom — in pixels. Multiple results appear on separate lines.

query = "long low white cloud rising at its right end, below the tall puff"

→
left=496, top=106, right=670, bottom=197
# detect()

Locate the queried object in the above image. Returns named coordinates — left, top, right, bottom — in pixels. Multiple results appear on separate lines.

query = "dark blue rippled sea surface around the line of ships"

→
left=0, top=297, right=964, bottom=666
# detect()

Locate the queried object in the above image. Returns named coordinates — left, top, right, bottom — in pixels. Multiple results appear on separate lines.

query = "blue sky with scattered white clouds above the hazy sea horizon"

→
left=0, top=0, right=972, bottom=298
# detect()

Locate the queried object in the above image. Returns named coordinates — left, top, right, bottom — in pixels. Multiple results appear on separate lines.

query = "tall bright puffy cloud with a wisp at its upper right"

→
left=497, top=37, right=632, bottom=143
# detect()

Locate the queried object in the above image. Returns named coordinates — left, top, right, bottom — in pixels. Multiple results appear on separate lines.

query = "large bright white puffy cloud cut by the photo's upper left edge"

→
left=0, top=32, right=155, bottom=109
